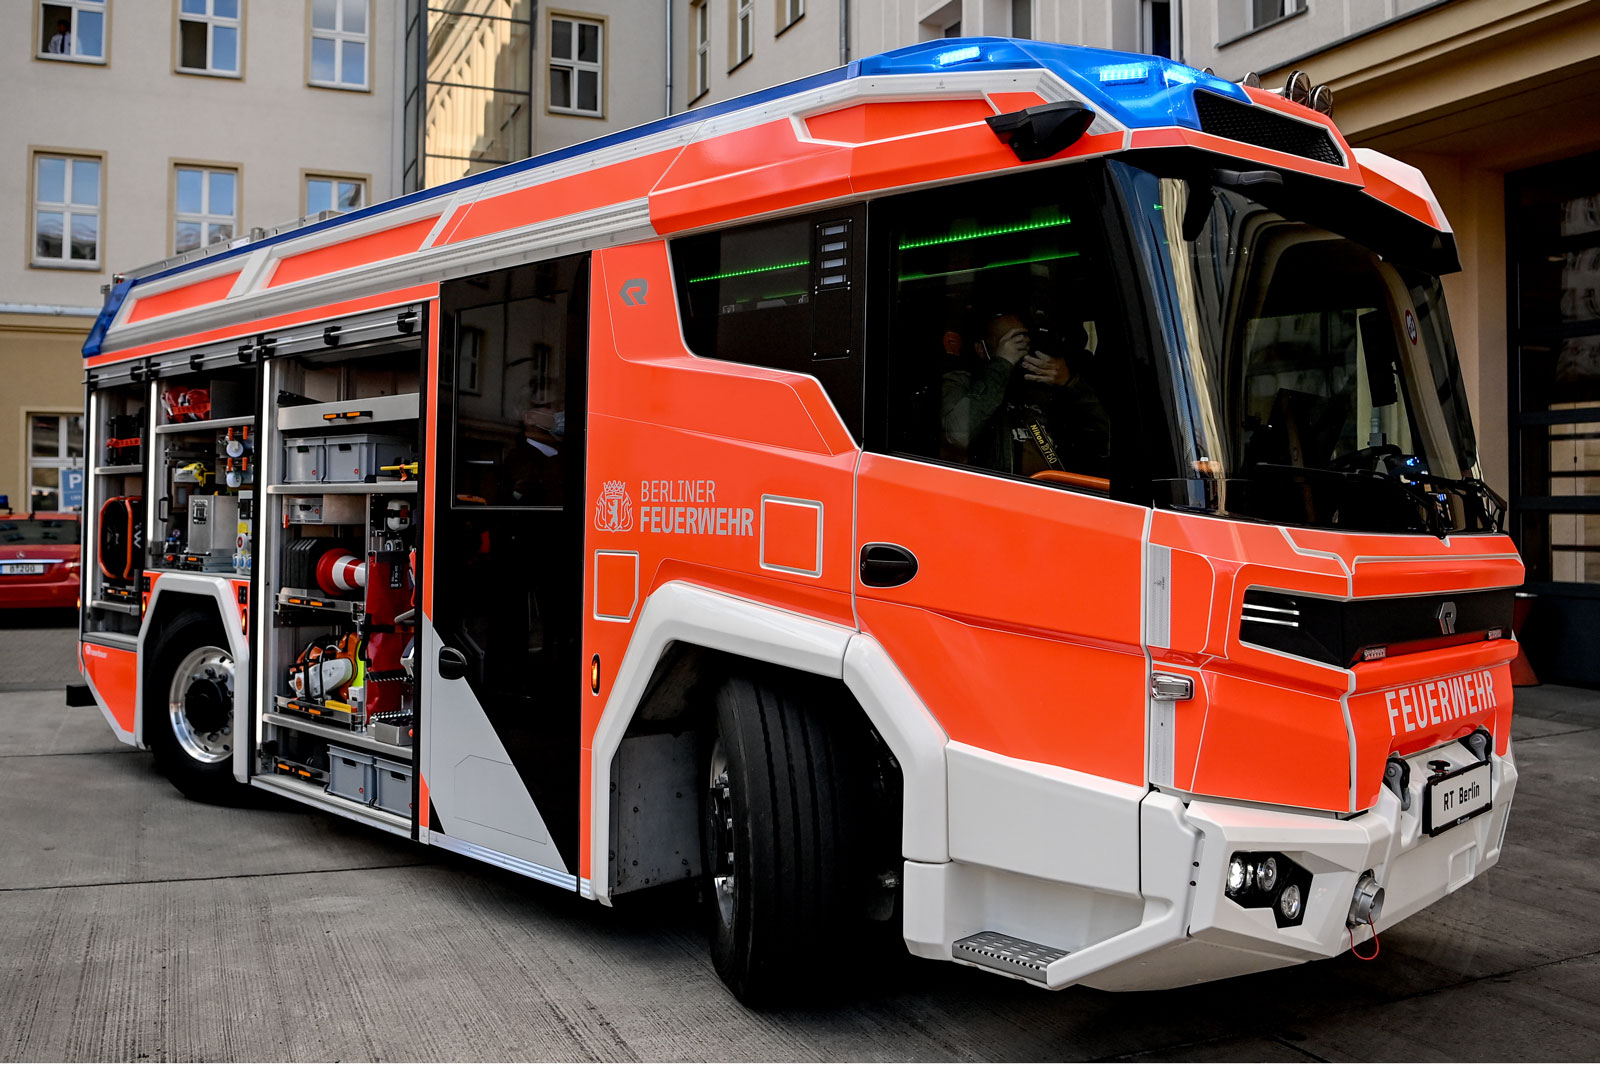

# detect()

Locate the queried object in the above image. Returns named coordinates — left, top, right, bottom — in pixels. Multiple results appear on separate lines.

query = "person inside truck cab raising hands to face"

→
left=941, top=310, right=1110, bottom=478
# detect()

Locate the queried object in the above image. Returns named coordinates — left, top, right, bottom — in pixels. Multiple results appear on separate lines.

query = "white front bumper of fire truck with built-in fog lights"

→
left=906, top=742, right=1517, bottom=990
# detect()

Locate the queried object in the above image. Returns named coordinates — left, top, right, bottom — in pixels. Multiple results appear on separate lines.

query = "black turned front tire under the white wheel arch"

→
left=701, top=672, right=864, bottom=1006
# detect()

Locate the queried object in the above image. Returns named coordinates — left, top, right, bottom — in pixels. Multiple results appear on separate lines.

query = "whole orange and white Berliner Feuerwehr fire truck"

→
left=80, top=38, right=1523, bottom=1001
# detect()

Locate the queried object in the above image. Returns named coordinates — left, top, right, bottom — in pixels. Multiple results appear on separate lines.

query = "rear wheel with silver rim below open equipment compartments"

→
left=144, top=609, right=245, bottom=805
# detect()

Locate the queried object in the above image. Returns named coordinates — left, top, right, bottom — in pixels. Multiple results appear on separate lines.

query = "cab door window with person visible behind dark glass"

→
left=874, top=170, right=1131, bottom=491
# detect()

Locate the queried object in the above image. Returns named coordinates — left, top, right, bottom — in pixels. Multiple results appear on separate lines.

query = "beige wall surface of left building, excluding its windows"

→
left=0, top=0, right=397, bottom=506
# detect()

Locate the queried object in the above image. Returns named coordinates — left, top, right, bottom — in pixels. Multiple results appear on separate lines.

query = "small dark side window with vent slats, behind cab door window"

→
left=672, top=206, right=864, bottom=440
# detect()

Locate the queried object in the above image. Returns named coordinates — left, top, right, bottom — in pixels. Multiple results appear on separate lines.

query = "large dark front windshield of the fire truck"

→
left=1114, top=165, right=1502, bottom=534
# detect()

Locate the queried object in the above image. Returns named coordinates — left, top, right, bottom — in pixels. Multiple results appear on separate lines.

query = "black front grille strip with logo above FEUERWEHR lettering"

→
left=1238, top=589, right=1514, bottom=667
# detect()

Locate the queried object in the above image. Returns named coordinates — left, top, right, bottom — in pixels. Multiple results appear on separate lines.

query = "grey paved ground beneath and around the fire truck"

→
left=0, top=619, right=1600, bottom=1061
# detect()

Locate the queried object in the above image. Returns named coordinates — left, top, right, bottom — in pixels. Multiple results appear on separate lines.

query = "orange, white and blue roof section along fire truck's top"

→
left=83, top=37, right=1448, bottom=363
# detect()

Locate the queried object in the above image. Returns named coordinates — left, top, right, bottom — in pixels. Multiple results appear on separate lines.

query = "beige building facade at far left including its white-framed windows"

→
left=0, top=0, right=400, bottom=512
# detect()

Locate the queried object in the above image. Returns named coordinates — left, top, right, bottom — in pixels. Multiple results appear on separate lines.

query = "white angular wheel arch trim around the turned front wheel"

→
left=581, top=582, right=949, bottom=904
